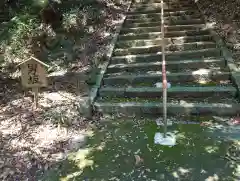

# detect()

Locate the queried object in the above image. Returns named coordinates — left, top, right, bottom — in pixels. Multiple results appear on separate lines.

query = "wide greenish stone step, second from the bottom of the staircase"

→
left=99, top=86, right=237, bottom=98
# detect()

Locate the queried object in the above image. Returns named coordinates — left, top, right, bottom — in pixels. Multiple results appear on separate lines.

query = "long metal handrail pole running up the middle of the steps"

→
left=161, top=0, right=167, bottom=137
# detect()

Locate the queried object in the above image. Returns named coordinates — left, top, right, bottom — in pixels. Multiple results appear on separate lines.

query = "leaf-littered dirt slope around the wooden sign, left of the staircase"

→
left=0, top=0, right=130, bottom=181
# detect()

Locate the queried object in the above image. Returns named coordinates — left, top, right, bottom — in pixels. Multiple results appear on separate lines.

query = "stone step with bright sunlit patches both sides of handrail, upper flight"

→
left=115, top=35, right=213, bottom=48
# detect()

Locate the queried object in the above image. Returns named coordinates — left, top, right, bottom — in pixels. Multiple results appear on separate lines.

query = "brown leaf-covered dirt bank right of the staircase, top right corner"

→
left=198, top=0, right=240, bottom=65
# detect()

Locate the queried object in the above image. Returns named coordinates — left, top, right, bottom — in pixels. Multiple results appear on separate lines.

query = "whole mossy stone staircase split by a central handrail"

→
left=94, top=0, right=240, bottom=116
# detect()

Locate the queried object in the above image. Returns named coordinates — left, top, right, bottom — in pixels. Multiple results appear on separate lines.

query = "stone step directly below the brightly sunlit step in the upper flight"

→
left=113, top=42, right=216, bottom=56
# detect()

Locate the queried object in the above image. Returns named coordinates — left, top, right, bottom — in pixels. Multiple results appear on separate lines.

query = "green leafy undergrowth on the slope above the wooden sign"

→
left=0, top=0, right=123, bottom=73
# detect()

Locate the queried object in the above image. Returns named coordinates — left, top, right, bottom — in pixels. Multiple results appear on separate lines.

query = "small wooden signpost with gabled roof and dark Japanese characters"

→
left=18, top=57, right=49, bottom=108
